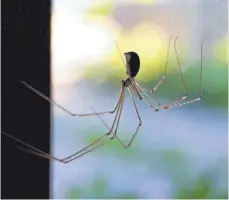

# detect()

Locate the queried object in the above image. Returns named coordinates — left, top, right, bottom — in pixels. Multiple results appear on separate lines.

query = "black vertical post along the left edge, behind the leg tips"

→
left=1, top=0, right=51, bottom=199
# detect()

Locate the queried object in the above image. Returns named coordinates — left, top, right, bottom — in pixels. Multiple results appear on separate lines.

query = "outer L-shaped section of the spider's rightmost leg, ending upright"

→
left=164, top=40, right=204, bottom=108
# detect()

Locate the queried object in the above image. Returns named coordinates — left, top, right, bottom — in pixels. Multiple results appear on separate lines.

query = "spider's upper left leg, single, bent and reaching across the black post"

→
left=20, top=81, right=122, bottom=117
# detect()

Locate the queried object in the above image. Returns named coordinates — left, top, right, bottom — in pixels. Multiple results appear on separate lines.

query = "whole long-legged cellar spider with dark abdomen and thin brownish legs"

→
left=2, top=37, right=204, bottom=163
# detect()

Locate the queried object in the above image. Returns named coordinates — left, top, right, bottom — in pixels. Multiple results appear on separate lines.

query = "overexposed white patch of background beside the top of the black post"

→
left=52, top=0, right=112, bottom=85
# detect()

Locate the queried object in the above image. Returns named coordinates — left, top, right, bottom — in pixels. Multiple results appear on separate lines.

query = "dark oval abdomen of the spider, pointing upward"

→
left=124, top=51, right=140, bottom=77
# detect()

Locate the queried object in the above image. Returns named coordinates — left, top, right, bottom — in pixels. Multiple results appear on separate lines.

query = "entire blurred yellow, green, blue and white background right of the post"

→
left=50, top=0, right=228, bottom=199
